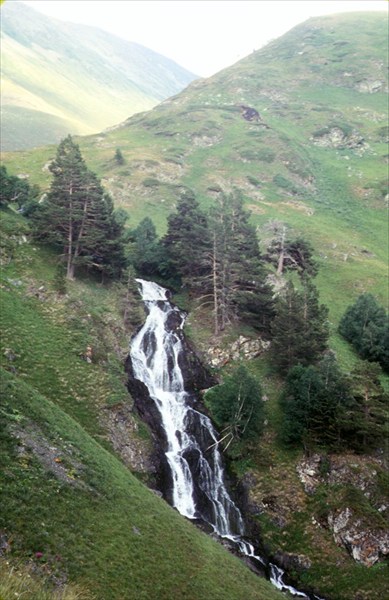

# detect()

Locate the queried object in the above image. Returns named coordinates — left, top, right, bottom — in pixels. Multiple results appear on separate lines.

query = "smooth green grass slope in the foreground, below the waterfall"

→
left=1, top=372, right=281, bottom=600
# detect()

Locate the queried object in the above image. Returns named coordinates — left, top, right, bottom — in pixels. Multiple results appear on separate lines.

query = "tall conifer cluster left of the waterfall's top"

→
left=32, top=136, right=124, bottom=279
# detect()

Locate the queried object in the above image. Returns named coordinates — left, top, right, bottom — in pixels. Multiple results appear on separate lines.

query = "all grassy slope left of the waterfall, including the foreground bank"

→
left=0, top=210, right=280, bottom=600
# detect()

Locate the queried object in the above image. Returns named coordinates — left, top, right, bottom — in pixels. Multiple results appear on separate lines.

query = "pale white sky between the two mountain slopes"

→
left=15, top=0, right=388, bottom=77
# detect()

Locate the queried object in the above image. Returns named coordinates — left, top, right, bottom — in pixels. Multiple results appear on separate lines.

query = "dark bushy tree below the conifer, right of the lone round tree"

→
left=281, top=354, right=352, bottom=449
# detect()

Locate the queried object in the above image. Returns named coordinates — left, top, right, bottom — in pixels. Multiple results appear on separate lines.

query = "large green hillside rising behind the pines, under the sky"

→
left=5, top=13, right=388, bottom=360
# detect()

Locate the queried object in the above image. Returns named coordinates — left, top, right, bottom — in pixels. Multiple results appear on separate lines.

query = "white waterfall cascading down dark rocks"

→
left=130, top=279, right=320, bottom=600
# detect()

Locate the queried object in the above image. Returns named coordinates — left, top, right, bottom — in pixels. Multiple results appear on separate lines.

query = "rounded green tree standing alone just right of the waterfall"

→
left=206, top=366, right=264, bottom=445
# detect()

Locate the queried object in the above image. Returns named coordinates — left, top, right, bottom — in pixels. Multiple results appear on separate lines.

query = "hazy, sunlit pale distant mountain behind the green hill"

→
left=1, top=1, right=196, bottom=150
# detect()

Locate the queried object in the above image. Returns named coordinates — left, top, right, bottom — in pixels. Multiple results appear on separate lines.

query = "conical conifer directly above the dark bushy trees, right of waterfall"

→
left=271, top=279, right=329, bottom=374
